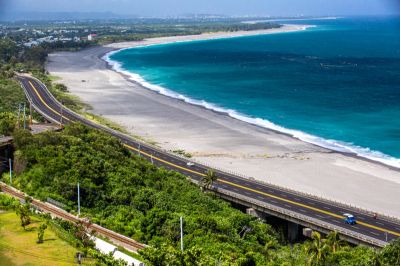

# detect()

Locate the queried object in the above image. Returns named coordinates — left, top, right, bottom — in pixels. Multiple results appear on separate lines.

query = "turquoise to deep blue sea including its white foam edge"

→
left=109, top=17, right=400, bottom=167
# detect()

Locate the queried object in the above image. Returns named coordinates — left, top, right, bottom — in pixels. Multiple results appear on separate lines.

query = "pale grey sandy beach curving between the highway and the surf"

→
left=47, top=23, right=400, bottom=218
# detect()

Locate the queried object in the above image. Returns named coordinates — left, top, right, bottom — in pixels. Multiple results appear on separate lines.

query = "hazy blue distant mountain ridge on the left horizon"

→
left=0, top=12, right=135, bottom=21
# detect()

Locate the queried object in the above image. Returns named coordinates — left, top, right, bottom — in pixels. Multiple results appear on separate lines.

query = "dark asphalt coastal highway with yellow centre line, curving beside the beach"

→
left=18, top=76, right=400, bottom=247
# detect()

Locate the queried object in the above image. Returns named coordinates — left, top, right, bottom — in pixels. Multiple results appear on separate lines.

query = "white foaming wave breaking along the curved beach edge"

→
left=102, top=52, right=400, bottom=168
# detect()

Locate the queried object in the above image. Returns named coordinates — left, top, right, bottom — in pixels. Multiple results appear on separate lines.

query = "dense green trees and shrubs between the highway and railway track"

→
left=4, top=124, right=400, bottom=265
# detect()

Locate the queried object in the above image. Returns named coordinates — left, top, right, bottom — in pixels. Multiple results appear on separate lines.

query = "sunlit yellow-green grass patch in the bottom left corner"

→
left=0, top=211, right=94, bottom=265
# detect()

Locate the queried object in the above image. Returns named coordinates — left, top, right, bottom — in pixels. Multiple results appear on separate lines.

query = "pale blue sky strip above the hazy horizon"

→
left=0, top=0, right=400, bottom=16
